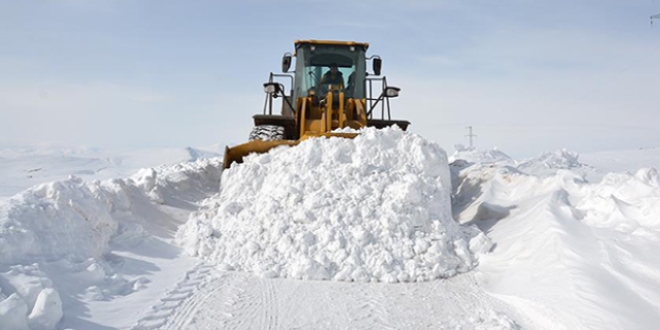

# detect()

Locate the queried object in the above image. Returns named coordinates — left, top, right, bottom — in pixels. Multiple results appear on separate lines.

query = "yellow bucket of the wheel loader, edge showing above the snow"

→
left=222, top=132, right=358, bottom=169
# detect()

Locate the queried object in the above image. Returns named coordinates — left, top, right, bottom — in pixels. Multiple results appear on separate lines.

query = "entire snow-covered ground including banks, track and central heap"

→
left=0, top=130, right=660, bottom=330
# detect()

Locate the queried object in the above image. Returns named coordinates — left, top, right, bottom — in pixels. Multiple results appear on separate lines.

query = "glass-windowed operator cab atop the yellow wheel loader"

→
left=293, top=40, right=369, bottom=100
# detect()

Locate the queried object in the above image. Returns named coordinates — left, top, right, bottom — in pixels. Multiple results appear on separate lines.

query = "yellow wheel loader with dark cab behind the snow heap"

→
left=223, top=40, right=410, bottom=168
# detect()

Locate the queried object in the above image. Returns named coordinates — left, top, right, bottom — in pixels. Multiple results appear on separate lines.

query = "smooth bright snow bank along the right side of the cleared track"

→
left=454, top=154, right=660, bottom=329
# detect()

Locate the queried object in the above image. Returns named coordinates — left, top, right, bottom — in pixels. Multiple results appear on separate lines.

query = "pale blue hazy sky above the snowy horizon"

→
left=0, top=0, right=660, bottom=156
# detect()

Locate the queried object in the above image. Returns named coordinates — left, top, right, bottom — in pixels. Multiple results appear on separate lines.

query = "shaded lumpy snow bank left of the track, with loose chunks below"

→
left=0, top=159, right=221, bottom=330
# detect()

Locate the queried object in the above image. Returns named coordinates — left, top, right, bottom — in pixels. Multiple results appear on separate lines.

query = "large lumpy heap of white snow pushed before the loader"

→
left=177, top=128, right=488, bottom=282
